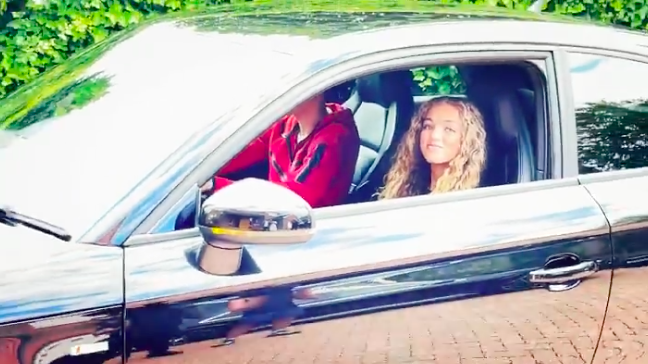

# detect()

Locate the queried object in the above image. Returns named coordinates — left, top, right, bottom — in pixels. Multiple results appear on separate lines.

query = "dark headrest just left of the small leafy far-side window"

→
left=357, top=71, right=412, bottom=108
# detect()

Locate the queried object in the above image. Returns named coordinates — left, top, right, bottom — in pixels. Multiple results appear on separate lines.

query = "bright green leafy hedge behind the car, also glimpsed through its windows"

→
left=0, top=0, right=648, bottom=98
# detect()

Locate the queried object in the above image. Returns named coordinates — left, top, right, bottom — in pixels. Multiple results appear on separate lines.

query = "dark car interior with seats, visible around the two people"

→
left=216, top=61, right=549, bottom=203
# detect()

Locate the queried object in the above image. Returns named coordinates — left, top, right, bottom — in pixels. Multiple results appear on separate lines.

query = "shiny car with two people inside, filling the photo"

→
left=0, top=3, right=648, bottom=364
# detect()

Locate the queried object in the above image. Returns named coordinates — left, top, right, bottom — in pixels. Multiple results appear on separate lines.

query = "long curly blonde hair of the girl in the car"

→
left=378, top=96, right=486, bottom=199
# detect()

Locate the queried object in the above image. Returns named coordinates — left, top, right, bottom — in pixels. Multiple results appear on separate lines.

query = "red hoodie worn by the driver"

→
left=214, top=104, right=360, bottom=208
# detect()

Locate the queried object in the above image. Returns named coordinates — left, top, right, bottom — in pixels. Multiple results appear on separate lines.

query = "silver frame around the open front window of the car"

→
left=124, top=42, right=563, bottom=246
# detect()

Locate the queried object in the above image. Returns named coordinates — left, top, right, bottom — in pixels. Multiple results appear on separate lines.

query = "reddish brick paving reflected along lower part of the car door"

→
left=129, top=272, right=612, bottom=364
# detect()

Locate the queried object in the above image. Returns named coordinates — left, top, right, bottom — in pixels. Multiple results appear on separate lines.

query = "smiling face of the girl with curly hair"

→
left=420, top=103, right=465, bottom=164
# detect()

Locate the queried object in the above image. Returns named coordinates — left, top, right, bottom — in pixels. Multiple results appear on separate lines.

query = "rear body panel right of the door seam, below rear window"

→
left=581, top=168, right=648, bottom=364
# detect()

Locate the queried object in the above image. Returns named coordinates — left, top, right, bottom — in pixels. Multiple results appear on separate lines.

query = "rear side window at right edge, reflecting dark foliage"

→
left=569, top=53, right=648, bottom=174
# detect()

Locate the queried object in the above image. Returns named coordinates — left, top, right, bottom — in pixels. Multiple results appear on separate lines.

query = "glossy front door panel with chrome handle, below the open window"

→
left=125, top=180, right=611, bottom=364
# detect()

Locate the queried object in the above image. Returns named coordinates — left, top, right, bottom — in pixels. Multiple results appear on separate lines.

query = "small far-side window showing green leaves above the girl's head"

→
left=410, top=65, right=466, bottom=97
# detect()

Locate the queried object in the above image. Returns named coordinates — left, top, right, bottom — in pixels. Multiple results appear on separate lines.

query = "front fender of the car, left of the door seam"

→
left=0, top=225, right=124, bottom=364
